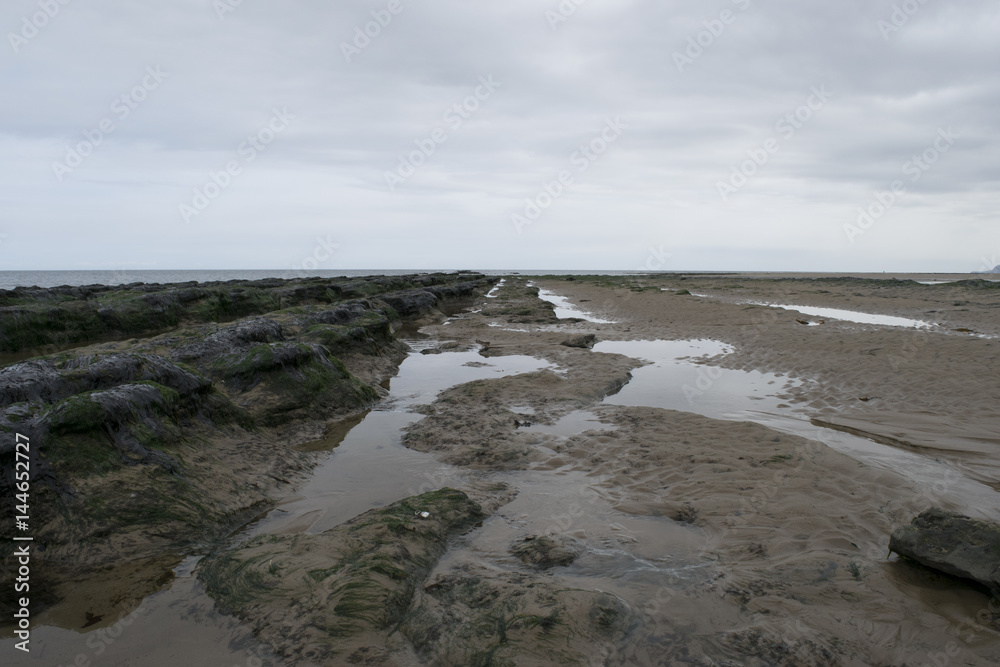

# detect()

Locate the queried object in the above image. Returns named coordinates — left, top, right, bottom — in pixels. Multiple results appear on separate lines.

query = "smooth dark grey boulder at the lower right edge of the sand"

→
left=889, top=508, right=1000, bottom=596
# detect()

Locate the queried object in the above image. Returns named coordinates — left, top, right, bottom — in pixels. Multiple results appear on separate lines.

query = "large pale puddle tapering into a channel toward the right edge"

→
left=594, top=340, right=1000, bottom=519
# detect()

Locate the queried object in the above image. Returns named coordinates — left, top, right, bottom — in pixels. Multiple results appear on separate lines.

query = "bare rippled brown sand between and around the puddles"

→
left=398, top=276, right=1000, bottom=665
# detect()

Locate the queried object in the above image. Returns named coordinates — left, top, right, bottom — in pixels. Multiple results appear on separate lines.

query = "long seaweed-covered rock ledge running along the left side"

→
left=0, top=273, right=495, bottom=612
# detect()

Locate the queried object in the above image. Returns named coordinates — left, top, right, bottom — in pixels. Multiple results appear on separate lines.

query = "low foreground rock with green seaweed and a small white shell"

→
left=199, top=488, right=483, bottom=664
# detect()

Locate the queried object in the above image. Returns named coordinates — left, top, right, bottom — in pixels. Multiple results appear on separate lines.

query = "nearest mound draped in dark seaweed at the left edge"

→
left=0, top=354, right=230, bottom=491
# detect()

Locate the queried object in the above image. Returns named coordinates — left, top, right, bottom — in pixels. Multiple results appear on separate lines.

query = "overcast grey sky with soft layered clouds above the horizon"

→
left=0, top=0, right=1000, bottom=271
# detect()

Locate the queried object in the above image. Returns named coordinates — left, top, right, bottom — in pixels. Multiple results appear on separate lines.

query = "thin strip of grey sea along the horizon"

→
left=0, top=269, right=639, bottom=289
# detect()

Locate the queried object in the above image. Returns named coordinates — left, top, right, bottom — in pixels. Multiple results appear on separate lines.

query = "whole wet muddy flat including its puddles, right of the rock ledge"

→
left=3, top=275, right=1000, bottom=666
